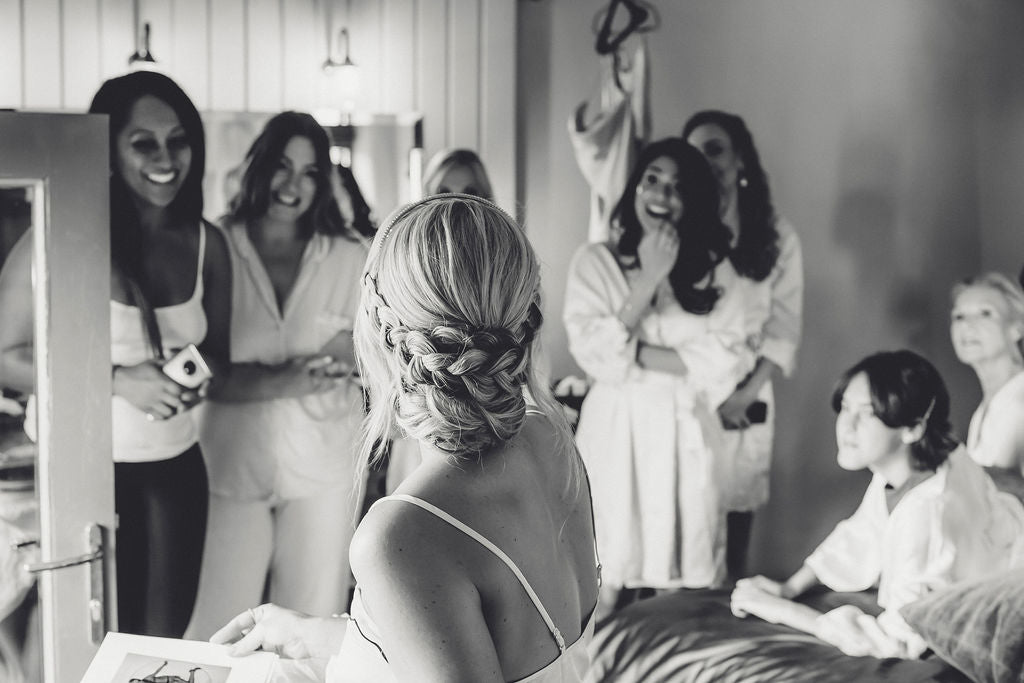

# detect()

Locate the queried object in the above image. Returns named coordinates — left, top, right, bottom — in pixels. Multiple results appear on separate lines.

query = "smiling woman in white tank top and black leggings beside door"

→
left=4, top=71, right=230, bottom=637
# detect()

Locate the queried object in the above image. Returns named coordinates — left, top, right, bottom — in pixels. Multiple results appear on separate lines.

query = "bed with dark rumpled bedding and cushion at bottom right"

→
left=587, top=473, right=1024, bottom=683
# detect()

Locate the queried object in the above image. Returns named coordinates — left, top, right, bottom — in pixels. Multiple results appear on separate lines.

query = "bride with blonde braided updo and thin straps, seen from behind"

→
left=213, top=195, right=599, bottom=681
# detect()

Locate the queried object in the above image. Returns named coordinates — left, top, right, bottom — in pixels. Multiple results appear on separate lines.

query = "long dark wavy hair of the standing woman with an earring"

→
left=683, top=110, right=779, bottom=282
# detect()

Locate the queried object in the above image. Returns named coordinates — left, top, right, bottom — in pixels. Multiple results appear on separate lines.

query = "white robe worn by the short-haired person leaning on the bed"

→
left=806, top=449, right=1024, bottom=657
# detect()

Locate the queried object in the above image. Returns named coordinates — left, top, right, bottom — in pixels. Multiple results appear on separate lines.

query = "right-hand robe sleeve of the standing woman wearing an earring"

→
left=761, top=219, right=804, bottom=377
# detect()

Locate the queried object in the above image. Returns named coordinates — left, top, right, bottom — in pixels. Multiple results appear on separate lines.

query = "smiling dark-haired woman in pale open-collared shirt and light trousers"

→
left=189, top=112, right=367, bottom=638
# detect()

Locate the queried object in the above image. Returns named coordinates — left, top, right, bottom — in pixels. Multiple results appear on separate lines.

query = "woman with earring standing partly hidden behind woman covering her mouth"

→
left=683, top=110, right=804, bottom=578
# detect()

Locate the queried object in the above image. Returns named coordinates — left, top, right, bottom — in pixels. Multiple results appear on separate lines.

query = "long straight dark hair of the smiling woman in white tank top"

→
left=89, top=71, right=206, bottom=290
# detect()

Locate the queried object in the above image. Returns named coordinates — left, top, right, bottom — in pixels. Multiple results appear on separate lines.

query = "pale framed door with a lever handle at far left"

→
left=0, top=111, right=117, bottom=683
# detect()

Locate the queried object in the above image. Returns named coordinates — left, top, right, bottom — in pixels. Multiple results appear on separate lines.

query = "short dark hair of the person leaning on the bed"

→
left=831, top=349, right=959, bottom=471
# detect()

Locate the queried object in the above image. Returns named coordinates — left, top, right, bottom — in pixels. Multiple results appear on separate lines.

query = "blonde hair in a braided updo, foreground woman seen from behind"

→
left=354, top=195, right=582, bottom=480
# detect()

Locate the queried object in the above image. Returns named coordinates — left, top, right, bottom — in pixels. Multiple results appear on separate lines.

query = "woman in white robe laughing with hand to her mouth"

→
left=564, top=138, right=753, bottom=609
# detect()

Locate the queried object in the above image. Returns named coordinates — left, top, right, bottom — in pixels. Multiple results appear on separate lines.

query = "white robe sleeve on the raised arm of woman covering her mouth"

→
left=562, top=244, right=639, bottom=382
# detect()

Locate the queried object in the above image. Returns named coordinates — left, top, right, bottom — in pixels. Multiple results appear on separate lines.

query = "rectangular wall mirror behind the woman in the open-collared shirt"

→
left=202, top=112, right=423, bottom=222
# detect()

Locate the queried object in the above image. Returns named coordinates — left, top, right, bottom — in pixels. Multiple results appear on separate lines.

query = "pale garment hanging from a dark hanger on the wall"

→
left=568, top=35, right=651, bottom=242
